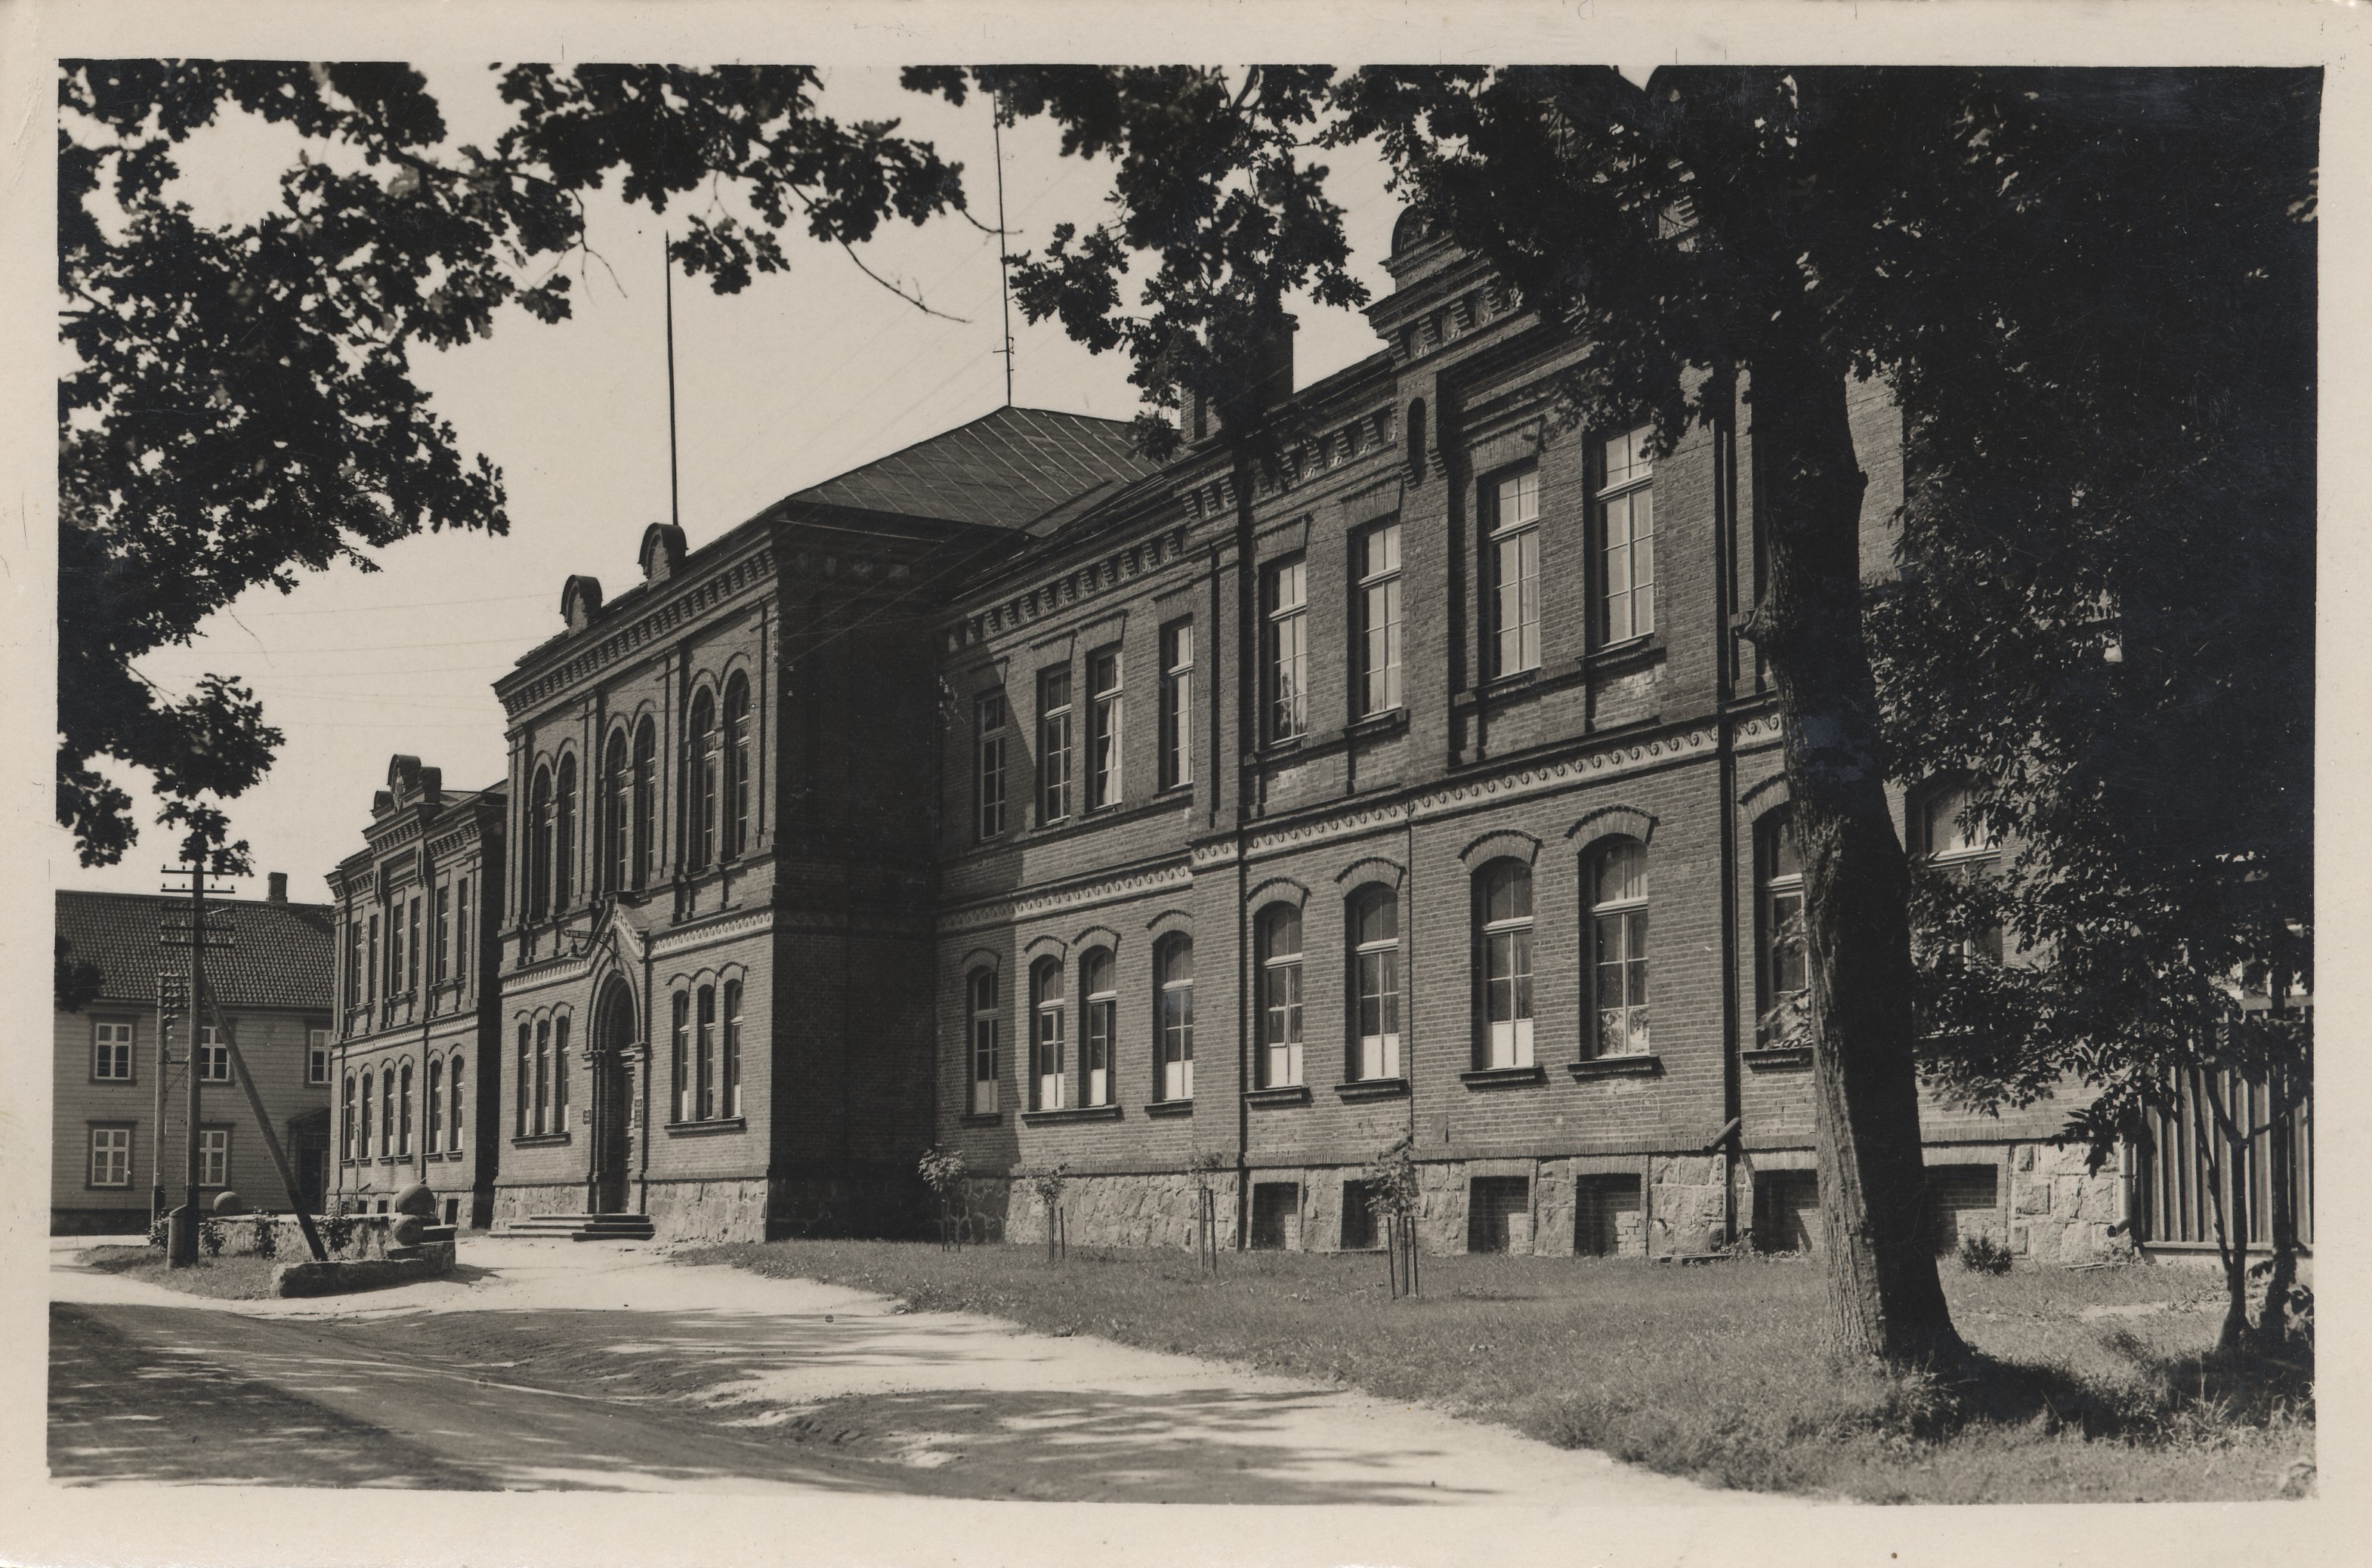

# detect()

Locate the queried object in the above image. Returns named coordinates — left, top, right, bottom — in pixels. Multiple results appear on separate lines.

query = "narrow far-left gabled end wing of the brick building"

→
left=329, top=757, right=508, bottom=1227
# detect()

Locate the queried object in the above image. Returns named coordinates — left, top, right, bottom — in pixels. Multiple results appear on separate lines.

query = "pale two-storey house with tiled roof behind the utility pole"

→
left=50, top=873, right=332, bottom=1233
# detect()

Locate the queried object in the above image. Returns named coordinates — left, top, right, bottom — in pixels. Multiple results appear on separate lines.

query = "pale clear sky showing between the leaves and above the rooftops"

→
left=50, top=66, right=1400, bottom=899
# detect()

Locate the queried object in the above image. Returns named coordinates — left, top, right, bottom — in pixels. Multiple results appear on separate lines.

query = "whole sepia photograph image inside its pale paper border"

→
left=26, top=9, right=2324, bottom=1556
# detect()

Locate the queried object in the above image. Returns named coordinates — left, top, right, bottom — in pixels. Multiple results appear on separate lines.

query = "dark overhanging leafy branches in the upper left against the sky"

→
left=57, top=62, right=963, bottom=866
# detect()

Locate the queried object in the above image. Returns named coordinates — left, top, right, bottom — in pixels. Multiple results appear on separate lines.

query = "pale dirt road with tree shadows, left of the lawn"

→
left=50, top=1241, right=1756, bottom=1506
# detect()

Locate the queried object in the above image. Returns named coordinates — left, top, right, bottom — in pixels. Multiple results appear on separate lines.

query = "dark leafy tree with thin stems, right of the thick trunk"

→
left=1871, top=71, right=2320, bottom=1347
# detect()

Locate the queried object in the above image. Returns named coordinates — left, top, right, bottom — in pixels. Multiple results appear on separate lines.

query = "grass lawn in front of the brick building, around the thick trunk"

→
left=676, top=1241, right=2315, bottom=1502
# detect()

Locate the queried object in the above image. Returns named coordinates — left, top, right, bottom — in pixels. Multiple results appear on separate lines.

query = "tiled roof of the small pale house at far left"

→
left=57, top=892, right=337, bottom=1013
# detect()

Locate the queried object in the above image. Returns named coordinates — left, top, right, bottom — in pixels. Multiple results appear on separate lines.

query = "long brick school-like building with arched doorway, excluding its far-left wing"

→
left=471, top=223, right=2306, bottom=1260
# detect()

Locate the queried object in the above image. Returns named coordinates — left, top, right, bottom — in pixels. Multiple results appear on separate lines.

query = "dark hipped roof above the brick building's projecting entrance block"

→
left=785, top=408, right=1153, bottom=529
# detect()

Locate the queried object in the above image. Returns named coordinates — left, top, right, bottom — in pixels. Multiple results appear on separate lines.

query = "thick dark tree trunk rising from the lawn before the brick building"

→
left=1748, top=344, right=1966, bottom=1366
